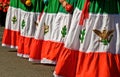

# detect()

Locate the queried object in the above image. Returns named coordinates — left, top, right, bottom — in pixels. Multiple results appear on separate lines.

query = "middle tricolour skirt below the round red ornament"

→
left=29, top=0, right=77, bottom=64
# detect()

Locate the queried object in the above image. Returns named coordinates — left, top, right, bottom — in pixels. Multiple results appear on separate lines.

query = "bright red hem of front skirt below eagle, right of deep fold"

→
left=76, top=53, right=120, bottom=77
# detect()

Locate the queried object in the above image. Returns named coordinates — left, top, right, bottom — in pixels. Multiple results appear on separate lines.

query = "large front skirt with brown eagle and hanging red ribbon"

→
left=54, top=0, right=120, bottom=77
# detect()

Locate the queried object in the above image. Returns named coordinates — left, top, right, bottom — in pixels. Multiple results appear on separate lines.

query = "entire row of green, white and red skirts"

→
left=2, top=0, right=120, bottom=77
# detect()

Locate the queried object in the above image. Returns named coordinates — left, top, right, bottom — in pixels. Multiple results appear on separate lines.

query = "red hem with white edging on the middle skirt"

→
left=30, top=39, right=64, bottom=64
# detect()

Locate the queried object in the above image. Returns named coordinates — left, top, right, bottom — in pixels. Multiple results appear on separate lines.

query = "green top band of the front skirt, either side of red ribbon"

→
left=77, top=0, right=120, bottom=14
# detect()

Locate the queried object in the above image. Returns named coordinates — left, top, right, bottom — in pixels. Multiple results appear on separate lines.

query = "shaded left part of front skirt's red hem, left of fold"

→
left=55, top=48, right=78, bottom=77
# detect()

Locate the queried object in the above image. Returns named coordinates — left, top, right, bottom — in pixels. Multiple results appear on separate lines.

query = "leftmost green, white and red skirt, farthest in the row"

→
left=2, top=0, right=20, bottom=48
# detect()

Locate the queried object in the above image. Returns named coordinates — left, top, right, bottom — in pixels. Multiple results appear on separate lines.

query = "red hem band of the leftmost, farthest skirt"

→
left=2, top=29, right=20, bottom=48
